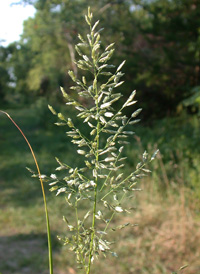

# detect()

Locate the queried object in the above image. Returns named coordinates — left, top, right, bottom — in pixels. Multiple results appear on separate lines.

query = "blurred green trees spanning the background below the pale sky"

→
left=0, top=0, right=200, bottom=120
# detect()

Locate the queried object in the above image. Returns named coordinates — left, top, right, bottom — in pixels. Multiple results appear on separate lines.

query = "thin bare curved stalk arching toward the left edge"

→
left=0, top=110, right=53, bottom=274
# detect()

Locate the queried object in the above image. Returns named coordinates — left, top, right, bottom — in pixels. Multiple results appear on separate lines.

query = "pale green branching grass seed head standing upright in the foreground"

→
left=45, top=8, right=158, bottom=274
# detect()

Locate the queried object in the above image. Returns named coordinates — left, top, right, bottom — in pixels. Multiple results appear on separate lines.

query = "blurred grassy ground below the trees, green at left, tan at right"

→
left=0, top=101, right=200, bottom=274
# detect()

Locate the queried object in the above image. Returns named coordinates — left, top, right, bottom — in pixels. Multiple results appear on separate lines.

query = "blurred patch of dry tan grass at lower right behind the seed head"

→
left=52, top=186, right=200, bottom=274
